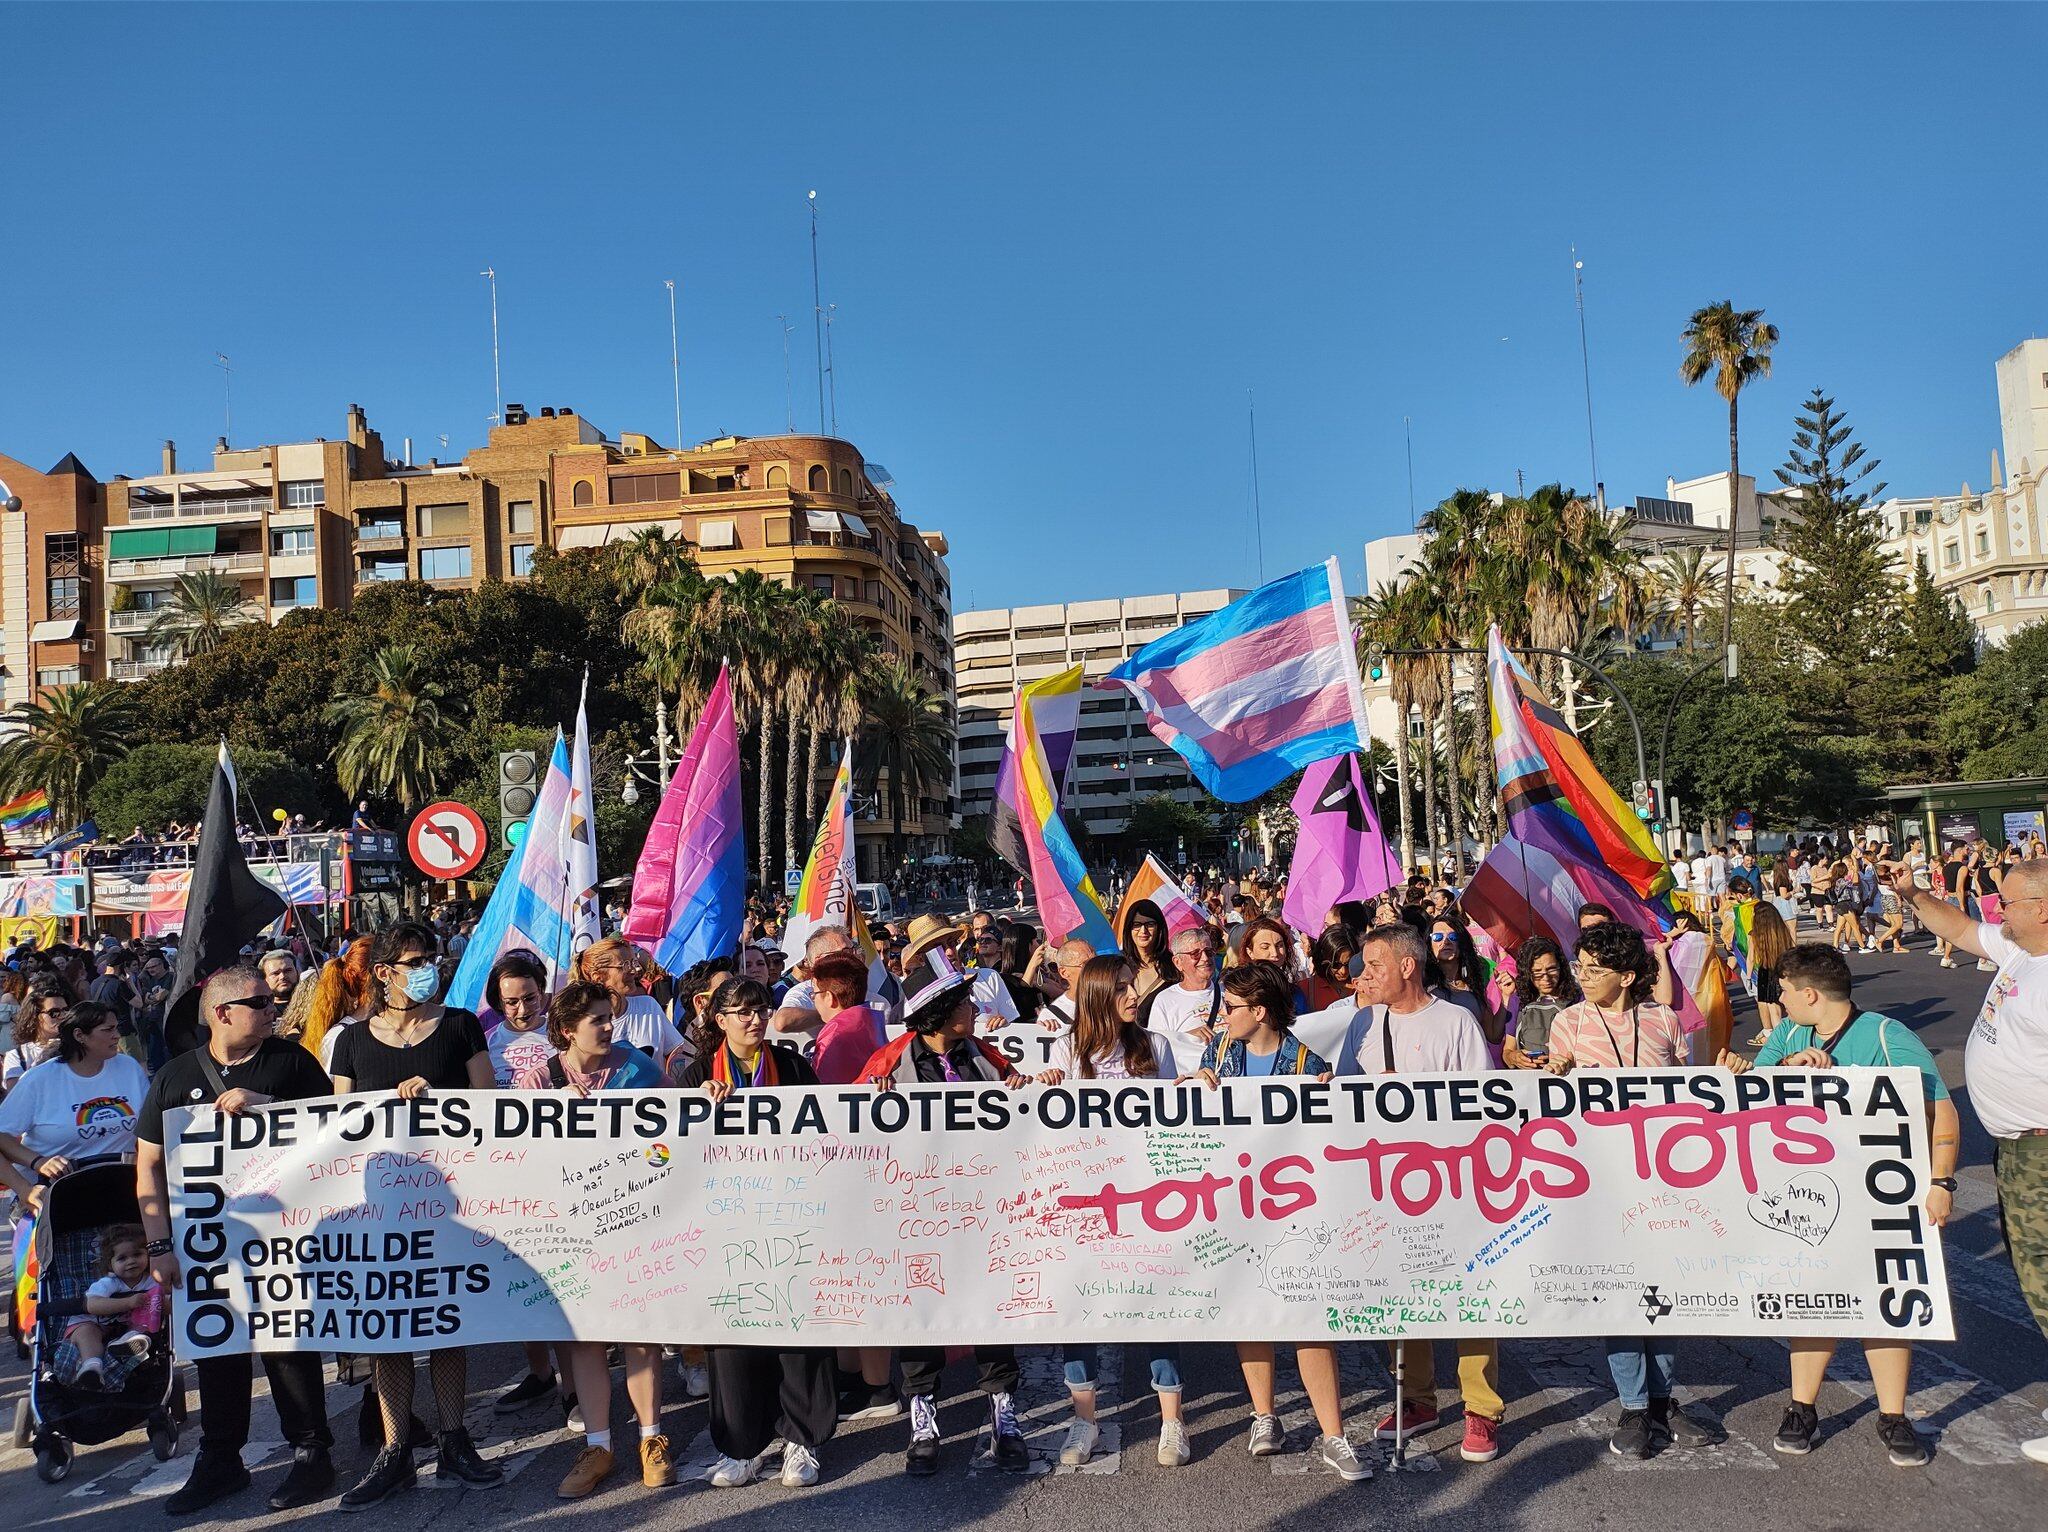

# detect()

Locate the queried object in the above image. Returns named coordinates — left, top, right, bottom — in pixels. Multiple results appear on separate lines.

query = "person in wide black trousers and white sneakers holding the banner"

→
left=682, top=974, right=831, bottom=1489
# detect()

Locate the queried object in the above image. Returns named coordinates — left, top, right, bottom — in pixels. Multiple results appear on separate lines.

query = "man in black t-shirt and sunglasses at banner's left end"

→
left=135, top=967, right=334, bottom=1516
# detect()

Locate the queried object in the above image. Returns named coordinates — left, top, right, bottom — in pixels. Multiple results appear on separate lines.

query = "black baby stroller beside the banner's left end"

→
left=14, top=1159, right=184, bottom=1485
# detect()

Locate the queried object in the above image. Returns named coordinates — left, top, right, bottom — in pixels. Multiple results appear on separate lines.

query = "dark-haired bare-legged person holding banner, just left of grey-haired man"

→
left=1194, top=963, right=1372, bottom=1481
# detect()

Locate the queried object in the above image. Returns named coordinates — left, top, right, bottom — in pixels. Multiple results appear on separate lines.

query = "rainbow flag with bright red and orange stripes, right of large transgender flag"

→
left=1487, top=629, right=1671, bottom=899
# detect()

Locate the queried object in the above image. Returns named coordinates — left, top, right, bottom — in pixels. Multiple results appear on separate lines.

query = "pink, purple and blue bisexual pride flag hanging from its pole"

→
left=625, top=666, right=748, bottom=973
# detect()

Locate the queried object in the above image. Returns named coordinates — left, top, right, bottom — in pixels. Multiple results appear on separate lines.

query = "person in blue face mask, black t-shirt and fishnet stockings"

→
left=332, top=920, right=504, bottom=1512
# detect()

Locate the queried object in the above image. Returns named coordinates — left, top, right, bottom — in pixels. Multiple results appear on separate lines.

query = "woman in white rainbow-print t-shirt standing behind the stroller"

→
left=0, top=1002, right=150, bottom=1208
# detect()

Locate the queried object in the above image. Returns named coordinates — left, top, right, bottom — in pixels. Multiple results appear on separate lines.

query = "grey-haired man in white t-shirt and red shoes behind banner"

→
left=1331, top=924, right=1505, bottom=1462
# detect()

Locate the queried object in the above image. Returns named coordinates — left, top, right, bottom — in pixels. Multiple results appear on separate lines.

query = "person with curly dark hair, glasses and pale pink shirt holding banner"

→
left=1544, top=920, right=1720, bottom=1458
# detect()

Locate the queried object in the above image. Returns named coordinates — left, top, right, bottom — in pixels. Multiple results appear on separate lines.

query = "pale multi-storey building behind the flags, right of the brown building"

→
left=952, top=590, right=1245, bottom=836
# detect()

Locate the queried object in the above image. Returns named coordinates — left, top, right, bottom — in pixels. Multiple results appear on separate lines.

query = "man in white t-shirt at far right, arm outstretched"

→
left=1884, top=860, right=2048, bottom=1464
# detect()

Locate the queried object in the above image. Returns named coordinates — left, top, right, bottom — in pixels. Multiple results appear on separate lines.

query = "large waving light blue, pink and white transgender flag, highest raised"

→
left=1096, top=559, right=1370, bottom=803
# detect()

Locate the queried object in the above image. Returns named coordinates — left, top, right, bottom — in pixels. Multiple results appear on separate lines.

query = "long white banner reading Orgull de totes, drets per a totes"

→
left=166, top=1069, right=1954, bottom=1356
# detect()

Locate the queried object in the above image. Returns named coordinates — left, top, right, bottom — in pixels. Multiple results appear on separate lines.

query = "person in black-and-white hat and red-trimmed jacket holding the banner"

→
left=860, top=946, right=1030, bottom=1477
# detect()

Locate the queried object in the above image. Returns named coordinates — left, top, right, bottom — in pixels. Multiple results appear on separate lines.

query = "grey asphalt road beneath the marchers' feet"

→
left=0, top=921, right=2048, bottom=1532
